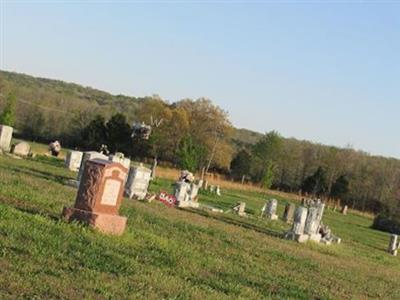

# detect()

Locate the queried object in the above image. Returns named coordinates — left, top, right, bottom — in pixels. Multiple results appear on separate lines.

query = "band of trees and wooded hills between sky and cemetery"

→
left=0, top=71, right=400, bottom=231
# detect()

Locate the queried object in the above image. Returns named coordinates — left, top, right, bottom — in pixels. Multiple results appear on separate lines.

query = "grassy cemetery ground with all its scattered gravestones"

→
left=0, top=136, right=400, bottom=299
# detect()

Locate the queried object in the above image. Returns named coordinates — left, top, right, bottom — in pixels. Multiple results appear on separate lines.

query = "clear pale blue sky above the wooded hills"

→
left=0, top=0, right=400, bottom=158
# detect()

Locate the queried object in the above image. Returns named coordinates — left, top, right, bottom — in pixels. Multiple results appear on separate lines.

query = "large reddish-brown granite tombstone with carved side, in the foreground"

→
left=63, top=159, right=127, bottom=235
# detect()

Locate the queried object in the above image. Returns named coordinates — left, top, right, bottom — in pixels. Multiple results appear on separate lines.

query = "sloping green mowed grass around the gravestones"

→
left=0, top=155, right=400, bottom=300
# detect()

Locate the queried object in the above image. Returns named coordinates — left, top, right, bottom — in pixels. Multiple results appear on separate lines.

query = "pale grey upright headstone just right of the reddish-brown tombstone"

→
left=125, top=164, right=151, bottom=200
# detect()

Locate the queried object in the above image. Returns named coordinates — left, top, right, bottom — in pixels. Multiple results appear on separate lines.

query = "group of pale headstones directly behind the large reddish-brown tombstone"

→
left=66, top=151, right=151, bottom=200
